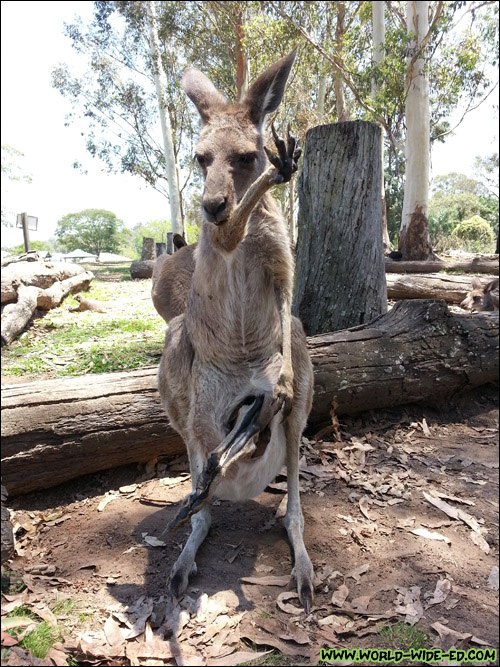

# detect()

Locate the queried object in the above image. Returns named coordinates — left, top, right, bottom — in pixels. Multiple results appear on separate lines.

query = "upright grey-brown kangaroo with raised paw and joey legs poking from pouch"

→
left=158, top=49, right=314, bottom=611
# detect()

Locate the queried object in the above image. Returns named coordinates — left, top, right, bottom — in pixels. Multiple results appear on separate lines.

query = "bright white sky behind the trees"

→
left=1, top=0, right=498, bottom=247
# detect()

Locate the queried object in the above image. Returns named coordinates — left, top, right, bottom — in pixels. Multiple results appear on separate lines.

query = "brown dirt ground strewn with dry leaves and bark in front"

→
left=4, top=378, right=499, bottom=665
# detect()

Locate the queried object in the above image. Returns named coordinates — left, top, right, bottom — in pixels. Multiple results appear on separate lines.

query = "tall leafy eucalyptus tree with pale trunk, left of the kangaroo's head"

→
left=52, top=2, right=195, bottom=234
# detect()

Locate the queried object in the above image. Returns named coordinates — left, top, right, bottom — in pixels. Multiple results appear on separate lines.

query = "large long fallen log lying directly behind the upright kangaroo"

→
left=2, top=301, right=499, bottom=495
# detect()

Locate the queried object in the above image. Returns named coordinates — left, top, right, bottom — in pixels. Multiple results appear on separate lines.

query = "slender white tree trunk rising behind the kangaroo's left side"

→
left=146, top=0, right=187, bottom=238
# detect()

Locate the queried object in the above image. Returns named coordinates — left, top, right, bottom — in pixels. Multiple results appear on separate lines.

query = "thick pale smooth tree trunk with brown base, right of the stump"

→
left=398, top=0, right=435, bottom=260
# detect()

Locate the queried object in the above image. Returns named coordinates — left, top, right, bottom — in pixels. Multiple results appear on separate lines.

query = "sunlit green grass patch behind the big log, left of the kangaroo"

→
left=2, top=265, right=166, bottom=378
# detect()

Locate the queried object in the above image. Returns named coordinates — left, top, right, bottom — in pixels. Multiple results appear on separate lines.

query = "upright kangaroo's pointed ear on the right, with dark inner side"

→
left=242, top=47, right=297, bottom=126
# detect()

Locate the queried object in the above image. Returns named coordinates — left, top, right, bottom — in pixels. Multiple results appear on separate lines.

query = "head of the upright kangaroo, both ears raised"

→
left=182, top=49, right=296, bottom=225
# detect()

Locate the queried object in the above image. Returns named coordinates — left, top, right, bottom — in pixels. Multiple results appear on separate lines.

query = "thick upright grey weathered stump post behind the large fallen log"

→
left=293, top=121, right=387, bottom=336
